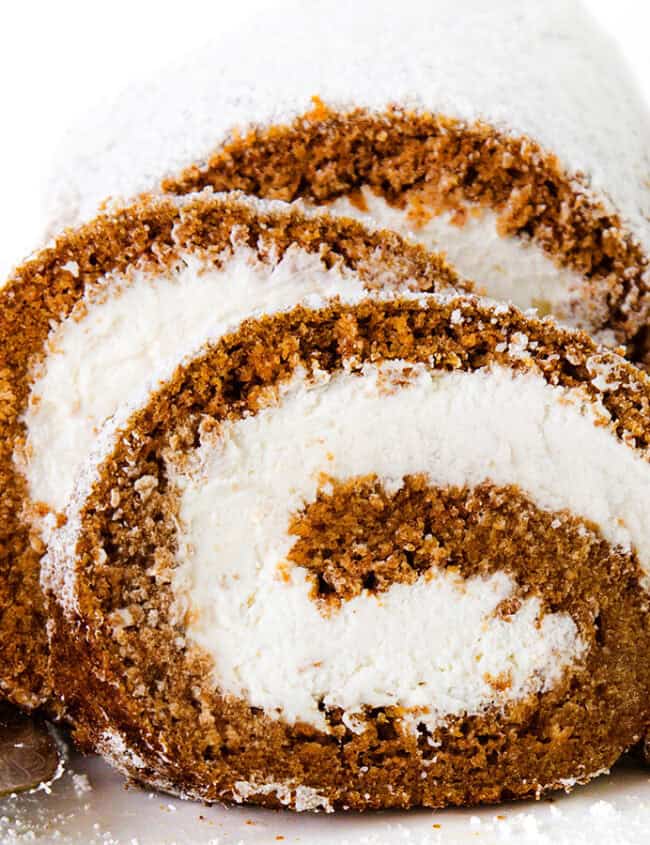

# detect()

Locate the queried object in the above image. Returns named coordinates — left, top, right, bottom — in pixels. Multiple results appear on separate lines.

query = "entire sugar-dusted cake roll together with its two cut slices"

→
left=0, top=0, right=650, bottom=811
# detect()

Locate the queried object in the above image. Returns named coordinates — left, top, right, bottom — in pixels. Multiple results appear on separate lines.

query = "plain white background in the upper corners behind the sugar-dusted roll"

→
left=0, top=0, right=650, bottom=275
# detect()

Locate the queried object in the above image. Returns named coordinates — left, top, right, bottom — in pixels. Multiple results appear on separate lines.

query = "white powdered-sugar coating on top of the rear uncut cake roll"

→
left=49, top=0, right=650, bottom=251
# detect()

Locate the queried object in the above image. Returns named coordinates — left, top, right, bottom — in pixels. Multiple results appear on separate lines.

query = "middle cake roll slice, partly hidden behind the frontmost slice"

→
left=0, top=197, right=468, bottom=708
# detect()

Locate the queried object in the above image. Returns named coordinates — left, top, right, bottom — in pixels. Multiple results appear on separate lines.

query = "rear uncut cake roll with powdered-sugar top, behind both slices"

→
left=50, top=0, right=650, bottom=360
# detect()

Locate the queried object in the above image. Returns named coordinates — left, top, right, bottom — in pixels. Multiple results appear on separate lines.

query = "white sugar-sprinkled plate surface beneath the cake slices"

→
left=0, top=755, right=650, bottom=845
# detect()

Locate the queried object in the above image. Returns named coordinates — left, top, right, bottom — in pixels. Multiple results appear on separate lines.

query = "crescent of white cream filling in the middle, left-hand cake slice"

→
left=19, top=247, right=374, bottom=511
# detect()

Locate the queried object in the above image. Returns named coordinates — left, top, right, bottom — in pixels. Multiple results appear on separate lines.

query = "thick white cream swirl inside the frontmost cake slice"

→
left=167, top=363, right=650, bottom=728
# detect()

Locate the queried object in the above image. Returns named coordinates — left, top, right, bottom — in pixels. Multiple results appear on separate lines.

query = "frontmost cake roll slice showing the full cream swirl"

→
left=43, top=256, right=650, bottom=811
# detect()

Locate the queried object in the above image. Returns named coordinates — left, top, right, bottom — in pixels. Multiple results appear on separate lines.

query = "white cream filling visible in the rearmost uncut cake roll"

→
left=327, top=188, right=584, bottom=322
